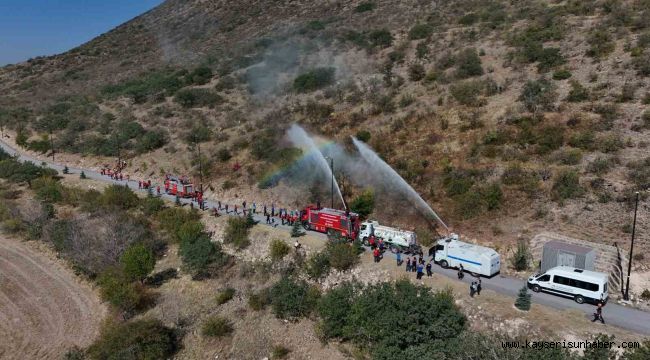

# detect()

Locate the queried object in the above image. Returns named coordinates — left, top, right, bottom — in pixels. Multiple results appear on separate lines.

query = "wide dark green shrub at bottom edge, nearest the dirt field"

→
left=87, top=319, right=180, bottom=360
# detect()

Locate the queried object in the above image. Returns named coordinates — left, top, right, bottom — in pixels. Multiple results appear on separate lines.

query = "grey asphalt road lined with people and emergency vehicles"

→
left=0, top=141, right=650, bottom=335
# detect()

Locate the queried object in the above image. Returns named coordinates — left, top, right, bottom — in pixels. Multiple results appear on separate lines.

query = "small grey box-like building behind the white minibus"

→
left=540, top=240, right=596, bottom=272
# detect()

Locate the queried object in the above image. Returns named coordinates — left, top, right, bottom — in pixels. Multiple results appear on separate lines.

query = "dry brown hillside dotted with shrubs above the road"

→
left=0, top=0, right=650, bottom=258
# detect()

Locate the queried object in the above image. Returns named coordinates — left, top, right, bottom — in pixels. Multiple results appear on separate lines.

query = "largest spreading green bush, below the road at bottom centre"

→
left=318, top=280, right=467, bottom=359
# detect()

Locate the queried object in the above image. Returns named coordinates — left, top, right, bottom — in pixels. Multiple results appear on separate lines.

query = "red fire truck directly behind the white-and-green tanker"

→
left=300, top=205, right=359, bottom=240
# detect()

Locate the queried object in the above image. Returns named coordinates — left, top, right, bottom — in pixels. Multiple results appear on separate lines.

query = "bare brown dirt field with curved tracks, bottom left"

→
left=0, top=237, right=106, bottom=359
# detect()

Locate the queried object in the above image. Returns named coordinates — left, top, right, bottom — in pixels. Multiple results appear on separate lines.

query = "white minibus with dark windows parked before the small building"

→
left=528, top=266, right=609, bottom=304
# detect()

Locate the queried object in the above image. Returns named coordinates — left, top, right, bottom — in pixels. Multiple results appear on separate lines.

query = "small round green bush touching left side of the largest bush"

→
left=270, top=278, right=320, bottom=319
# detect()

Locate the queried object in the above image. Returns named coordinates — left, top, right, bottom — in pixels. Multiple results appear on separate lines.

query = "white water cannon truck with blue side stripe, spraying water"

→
left=429, top=234, right=501, bottom=277
